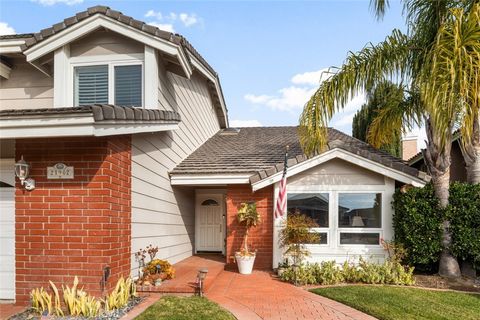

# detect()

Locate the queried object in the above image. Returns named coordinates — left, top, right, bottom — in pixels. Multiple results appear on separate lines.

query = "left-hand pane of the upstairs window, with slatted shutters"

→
left=75, top=65, right=108, bottom=106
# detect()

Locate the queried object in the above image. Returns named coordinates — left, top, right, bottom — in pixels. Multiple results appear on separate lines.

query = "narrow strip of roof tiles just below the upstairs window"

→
left=0, top=104, right=180, bottom=122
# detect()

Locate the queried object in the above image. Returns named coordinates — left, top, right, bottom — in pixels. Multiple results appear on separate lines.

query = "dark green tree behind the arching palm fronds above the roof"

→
left=352, top=81, right=404, bottom=157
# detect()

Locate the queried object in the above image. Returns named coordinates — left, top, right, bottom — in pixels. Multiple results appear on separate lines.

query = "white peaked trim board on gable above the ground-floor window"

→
left=252, top=148, right=426, bottom=191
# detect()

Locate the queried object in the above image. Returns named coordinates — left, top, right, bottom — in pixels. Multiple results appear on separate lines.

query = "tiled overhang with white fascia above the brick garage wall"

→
left=0, top=105, right=180, bottom=139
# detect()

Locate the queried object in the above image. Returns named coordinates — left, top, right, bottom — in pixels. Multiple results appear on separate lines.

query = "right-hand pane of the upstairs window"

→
left=115, top=65, right=142, bottom=107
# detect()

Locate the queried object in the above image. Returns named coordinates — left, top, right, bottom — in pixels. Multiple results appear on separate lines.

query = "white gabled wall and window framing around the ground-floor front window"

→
left=273, top=159, right=395, bottom=268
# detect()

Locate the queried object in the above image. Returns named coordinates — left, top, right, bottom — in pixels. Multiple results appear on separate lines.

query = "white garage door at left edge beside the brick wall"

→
left=0, top=159, right=15, bottom=300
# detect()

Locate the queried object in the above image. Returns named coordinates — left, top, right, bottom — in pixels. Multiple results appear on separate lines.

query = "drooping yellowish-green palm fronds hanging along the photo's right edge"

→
left=420, top=4, right=480, bottom=149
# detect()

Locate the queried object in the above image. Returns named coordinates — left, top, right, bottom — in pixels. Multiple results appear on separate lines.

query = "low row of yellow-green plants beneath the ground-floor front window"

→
left=280, top=258, right=415, bottom=285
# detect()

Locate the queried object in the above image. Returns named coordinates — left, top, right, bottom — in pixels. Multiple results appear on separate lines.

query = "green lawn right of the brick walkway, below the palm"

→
left=311, top=286, right=480, bottom=320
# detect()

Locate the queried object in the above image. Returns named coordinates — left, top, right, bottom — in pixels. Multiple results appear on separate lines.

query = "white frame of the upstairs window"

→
left=67, top=53, right=145, bottom=108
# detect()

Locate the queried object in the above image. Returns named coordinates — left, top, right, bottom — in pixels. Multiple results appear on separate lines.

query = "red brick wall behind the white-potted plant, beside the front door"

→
left=227, top=185, right=273, bottom=269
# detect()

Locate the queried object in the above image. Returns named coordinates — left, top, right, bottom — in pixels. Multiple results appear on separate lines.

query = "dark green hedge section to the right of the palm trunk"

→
left=447, top=183, right=480, bottom=269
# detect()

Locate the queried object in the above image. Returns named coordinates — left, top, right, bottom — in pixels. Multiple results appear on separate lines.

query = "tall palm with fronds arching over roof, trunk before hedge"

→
left=299, top=0, right=480, bottom=277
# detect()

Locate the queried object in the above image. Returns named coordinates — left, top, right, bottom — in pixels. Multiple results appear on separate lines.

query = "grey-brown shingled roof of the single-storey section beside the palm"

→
left=171, top=127, right=428, bottom=183
